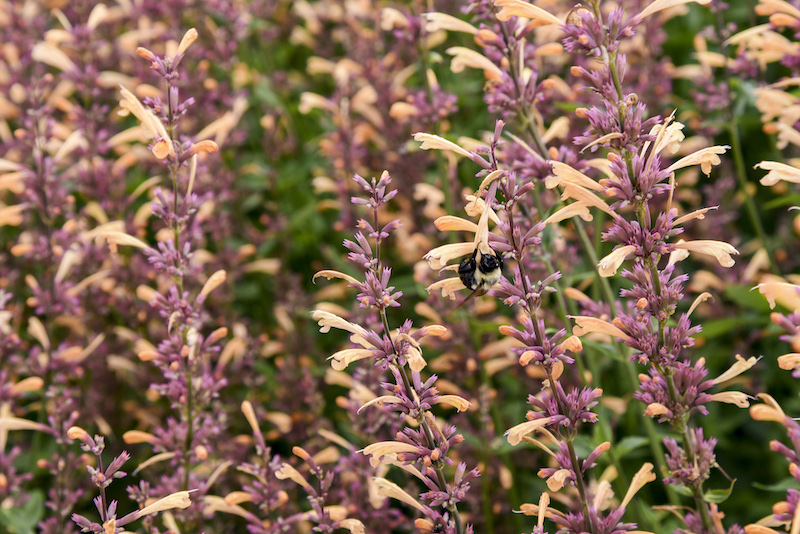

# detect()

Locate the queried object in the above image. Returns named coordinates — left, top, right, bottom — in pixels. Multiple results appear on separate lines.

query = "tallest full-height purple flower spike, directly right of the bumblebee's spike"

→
left=532, top=0, right=756, bottom=532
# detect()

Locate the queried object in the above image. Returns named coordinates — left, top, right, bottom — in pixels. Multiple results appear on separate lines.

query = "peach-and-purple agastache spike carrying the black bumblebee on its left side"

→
left=417, top=121, right=655, bottom=534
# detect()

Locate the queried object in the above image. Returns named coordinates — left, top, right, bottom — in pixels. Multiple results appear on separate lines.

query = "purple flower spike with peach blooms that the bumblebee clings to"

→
left=416, top=121, right=640, bottom=533
